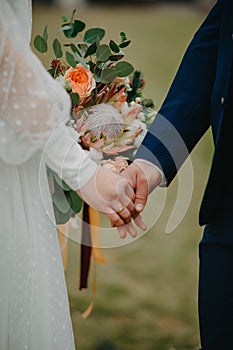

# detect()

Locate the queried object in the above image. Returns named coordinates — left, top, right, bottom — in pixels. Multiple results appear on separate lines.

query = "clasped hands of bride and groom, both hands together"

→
left=77, top=161, right=161, bottom=238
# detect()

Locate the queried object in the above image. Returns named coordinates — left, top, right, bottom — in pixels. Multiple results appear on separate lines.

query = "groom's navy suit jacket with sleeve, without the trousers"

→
left=136, top=0, right=233, bottom=225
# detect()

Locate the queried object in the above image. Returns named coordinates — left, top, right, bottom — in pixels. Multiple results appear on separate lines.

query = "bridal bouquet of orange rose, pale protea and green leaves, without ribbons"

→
left=34, top=10, right=155, bottom=224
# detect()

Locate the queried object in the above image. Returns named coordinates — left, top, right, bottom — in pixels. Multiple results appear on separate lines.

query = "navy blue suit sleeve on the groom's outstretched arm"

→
left=135, top=1, right=223, bottom=186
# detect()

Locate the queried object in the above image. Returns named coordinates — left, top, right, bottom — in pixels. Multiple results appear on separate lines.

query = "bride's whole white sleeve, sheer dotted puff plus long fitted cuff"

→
left=0, top=0, right=96, bottom=189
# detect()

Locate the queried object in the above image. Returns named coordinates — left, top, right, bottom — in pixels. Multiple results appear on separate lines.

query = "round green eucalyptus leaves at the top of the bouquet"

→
left=34, top=10, right=134, bottom=84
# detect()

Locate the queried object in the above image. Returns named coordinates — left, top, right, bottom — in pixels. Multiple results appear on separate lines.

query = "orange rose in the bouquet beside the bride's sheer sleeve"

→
left=65, top=63, right=95, bottom=98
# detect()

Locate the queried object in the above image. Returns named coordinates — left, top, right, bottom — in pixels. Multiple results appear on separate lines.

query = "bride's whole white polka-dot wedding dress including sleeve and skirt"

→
left=0, top=0, right=96, bottom=350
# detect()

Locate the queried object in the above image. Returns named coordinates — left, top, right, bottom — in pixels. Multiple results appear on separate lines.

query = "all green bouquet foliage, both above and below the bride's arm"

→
left=31, top=10, right=134, bottom=224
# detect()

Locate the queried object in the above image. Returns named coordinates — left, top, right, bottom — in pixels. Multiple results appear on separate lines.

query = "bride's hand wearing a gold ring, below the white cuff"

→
left=77, top=167, right=141, bottom=237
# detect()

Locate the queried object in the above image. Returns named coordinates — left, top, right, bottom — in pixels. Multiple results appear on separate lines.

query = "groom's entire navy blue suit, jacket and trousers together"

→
left=136, top=0, right=233, bottom=350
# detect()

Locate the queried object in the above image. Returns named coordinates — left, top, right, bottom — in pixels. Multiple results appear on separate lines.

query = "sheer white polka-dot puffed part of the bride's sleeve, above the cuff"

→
left=0, top=0, right=70, bottom=164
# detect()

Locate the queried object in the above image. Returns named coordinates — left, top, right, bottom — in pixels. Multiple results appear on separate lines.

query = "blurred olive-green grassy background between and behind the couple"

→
left=32, top=0, right=214, bottom=350
